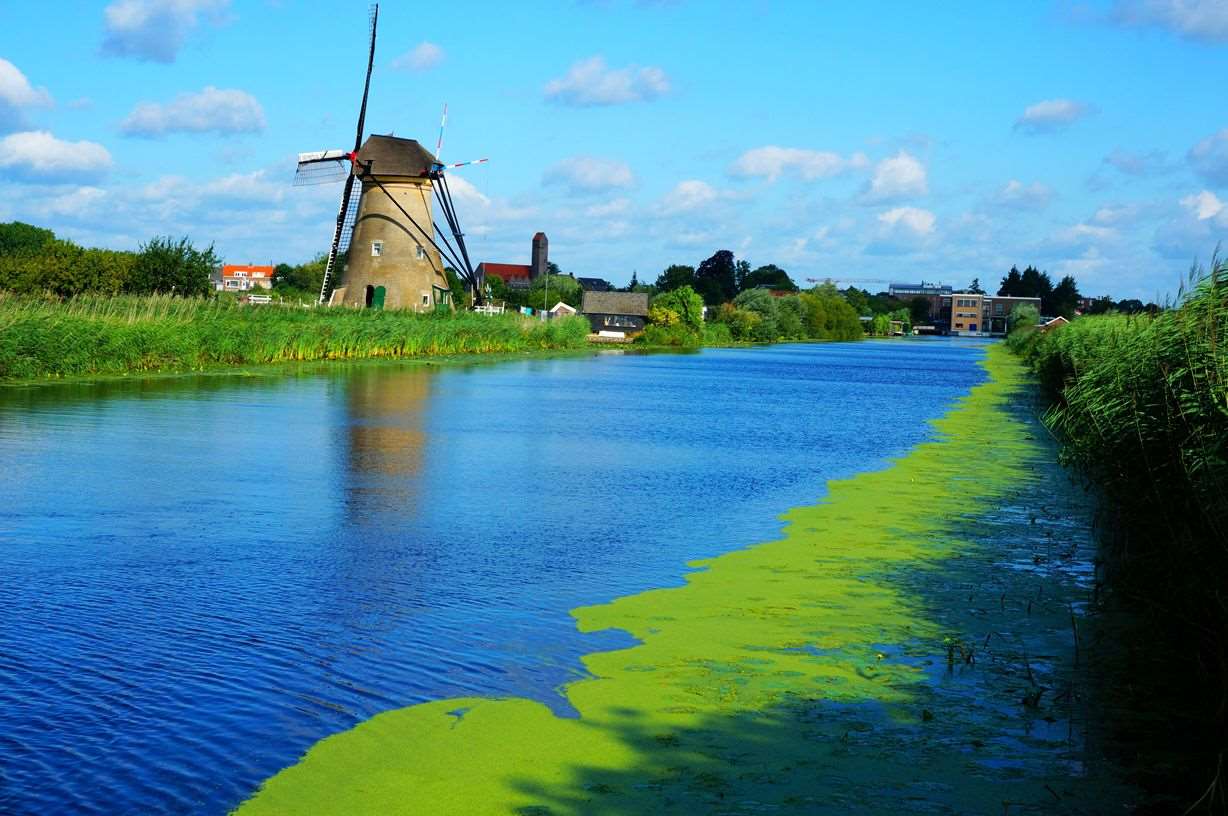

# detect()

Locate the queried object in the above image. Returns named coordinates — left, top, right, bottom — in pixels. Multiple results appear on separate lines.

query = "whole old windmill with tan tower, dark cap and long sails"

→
left=295, top=5, right=486, bottom=311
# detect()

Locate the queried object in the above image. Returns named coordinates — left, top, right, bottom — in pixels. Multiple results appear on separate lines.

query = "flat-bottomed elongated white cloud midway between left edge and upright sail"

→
left=119, top=85, right=264, bottom=138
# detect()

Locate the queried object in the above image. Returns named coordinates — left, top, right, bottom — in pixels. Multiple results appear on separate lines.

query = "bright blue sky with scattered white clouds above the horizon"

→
left=0, top=0, right=1228, bottom=299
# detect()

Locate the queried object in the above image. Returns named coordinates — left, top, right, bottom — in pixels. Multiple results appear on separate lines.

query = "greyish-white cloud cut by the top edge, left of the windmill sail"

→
left=102, top=0, right=230, bottom=63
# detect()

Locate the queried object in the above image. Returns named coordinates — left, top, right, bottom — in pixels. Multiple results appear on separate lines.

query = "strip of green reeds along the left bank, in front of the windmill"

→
left=0, top=292, right=588, bottom=381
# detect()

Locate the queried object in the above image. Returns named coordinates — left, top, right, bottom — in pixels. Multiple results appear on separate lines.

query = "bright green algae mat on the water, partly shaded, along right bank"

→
left=237, top=345, right=1127, bottom=816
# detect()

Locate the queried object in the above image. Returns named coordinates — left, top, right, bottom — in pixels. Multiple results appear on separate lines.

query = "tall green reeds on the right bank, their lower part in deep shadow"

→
left=1011, top=262, right=1228, bottom=812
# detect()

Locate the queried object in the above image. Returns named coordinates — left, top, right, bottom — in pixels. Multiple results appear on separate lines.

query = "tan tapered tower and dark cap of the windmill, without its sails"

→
left=329, top=135, right=452, bottom=312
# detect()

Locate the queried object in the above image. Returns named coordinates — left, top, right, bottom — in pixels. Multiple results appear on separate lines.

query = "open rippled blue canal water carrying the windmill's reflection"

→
left=0, top=339, right=984, bottom=814
